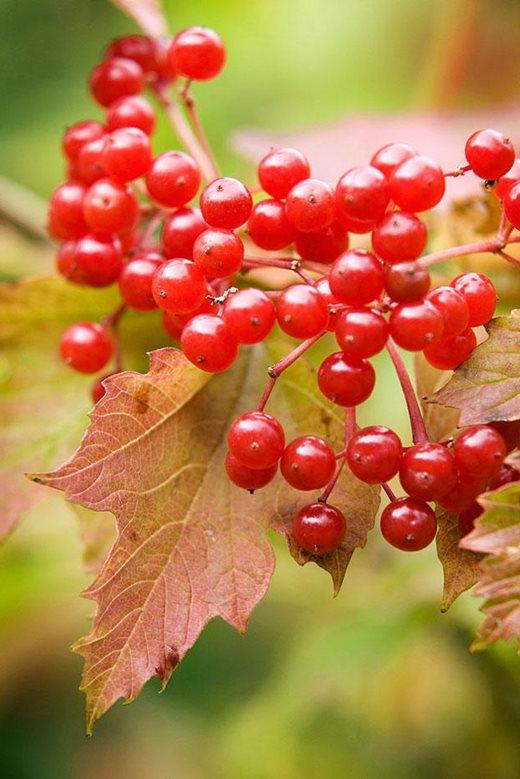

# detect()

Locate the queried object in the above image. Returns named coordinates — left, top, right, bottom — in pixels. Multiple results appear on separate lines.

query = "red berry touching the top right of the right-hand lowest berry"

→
left=399, top=443, right=457, bottom=501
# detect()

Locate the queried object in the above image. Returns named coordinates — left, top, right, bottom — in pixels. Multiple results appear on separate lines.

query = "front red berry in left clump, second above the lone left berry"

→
left=83, top=179, right=139, bottom=233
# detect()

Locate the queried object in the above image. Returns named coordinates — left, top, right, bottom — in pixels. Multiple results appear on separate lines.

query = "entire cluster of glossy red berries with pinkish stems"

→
left=48, top=27, right=520, bottom=556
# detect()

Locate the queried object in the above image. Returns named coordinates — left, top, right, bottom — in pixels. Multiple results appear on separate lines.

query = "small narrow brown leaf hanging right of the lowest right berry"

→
left=435, top=509, right=480, bottom=611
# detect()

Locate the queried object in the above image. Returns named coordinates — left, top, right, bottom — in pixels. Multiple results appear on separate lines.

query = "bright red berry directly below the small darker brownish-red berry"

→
left=390, top=301, right=444, bottom=352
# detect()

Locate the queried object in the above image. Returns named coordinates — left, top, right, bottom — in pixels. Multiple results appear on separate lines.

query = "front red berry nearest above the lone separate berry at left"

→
left=74, top=233, right=123, bottom=287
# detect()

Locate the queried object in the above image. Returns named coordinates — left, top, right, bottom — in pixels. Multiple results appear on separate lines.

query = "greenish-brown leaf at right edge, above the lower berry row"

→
left=428, top=309, right=520, bottom=426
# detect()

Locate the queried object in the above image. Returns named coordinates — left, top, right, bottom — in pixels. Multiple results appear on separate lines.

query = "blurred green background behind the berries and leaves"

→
left=0, top=0, right=520, bottom=779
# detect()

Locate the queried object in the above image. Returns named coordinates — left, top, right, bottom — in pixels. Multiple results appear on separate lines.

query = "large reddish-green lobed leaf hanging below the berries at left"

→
left=35, top=340, right=377, bottom=732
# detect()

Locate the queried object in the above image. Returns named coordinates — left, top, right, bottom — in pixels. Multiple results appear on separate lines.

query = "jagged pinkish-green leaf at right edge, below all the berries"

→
left=460, top=482, right=520, bottom=650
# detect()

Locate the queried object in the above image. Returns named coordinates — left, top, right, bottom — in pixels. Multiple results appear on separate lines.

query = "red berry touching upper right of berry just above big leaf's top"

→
left=222, top=287, right=276, bottom=344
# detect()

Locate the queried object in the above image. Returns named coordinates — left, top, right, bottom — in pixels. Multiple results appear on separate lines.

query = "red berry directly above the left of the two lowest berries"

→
left=280, top=435, right=336, bottom=490
